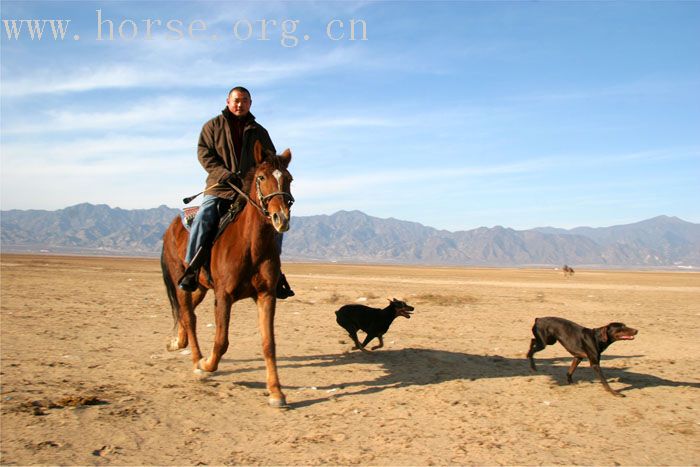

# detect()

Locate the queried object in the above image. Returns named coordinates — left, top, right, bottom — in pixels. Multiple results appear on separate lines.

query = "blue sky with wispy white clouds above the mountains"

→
left=0, top=1, right=700, bottom=231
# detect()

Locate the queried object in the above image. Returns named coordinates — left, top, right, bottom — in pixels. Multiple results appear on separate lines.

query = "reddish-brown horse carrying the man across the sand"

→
left=161, top=142, right=294, bottom=407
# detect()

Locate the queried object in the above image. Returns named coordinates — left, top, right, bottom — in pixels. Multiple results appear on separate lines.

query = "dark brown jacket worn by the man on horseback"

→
left=197, top=108, right=275, bottom=199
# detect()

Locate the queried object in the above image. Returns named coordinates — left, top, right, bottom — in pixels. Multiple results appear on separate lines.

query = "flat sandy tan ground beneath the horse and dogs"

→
left=0, top=255, right=700, bottom=465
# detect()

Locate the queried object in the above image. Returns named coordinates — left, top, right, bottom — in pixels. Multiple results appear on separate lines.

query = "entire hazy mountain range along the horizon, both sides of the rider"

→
left=0, top=203, right=700, bottom=268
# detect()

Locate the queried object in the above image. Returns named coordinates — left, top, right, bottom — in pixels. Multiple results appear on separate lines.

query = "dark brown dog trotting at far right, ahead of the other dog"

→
left=527, top=317, right=637, bottom=397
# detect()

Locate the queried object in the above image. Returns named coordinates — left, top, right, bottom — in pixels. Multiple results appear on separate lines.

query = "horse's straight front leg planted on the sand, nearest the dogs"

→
left=257, top=294, right=287, bottom=407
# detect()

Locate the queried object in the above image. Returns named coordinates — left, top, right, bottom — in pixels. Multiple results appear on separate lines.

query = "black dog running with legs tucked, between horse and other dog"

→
left=335, top=299, right=413, bottom=352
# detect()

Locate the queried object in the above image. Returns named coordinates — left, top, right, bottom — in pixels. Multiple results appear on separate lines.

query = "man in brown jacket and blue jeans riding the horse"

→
left=178, top=86, right=294, bottom=299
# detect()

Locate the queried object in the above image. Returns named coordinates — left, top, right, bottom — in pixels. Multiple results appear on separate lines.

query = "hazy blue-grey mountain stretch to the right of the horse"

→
left=284, top=211, right=700, bottom=267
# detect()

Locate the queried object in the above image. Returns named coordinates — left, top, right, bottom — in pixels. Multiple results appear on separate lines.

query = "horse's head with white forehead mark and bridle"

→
left=250, top=141, right=294, bottom=233
